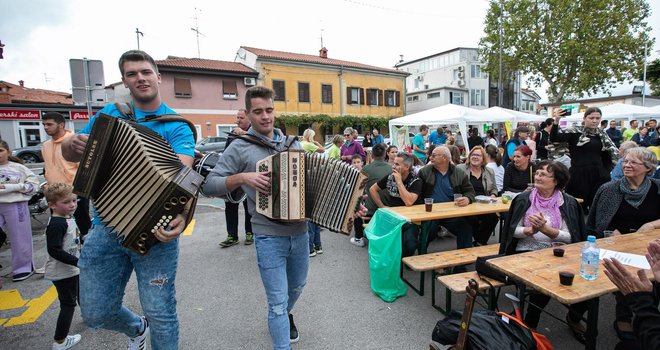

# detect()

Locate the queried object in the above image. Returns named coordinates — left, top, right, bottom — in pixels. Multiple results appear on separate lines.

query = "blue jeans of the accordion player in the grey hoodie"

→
left=254, top=233, right=309, bottom=350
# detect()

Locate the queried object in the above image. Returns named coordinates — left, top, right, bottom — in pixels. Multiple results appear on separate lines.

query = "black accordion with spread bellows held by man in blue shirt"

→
left=73, top=114, right=204, bottom=255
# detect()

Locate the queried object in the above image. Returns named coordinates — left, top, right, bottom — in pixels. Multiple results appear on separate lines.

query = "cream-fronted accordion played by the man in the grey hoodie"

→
left=256, top=150, right=367, bottom=234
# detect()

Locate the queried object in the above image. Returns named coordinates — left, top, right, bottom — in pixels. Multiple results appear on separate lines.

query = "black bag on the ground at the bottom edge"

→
left=431, top=310, right=536, bottom=350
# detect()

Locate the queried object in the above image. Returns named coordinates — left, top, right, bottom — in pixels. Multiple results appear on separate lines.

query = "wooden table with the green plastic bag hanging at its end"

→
left=379, top=198, right=511, bottom=295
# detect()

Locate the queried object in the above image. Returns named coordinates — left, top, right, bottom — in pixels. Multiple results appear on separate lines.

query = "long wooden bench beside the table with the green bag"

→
left=401, top=244, right=500, bottom=297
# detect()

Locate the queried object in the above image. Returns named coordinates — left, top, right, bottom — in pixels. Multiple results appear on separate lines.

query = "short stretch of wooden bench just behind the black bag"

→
left=432, top=271, right=506, bottom=315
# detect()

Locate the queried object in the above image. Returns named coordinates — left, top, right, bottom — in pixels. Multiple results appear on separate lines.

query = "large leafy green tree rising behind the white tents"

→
left=479, top=0, right=654, bottom=102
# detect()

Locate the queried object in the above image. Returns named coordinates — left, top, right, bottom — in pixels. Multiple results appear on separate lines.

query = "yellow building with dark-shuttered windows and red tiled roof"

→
left=235, top=46, right=409, bottom=119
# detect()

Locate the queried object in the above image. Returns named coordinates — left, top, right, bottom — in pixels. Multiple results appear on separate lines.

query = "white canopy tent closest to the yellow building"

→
left=389, top=104, right=488, bottom=147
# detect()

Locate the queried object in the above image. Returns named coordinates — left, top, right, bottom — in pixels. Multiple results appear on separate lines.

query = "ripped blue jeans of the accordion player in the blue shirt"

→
left=78, top=224, right=179, bottom=350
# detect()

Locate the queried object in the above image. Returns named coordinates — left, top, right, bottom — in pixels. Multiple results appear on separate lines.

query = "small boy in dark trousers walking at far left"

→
left=44, top=183, right=81, bottom=350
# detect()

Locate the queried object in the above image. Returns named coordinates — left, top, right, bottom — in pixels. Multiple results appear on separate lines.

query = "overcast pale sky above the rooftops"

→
left=0, top=0, right=660, bottom=103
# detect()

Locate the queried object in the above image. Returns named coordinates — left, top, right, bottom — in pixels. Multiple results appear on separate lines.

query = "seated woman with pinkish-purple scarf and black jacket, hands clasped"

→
left=500, top=160, right=587, bottom=342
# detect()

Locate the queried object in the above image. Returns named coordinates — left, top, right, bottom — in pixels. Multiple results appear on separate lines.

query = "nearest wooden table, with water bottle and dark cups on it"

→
left=488, top=230, right=660, bottom=349
